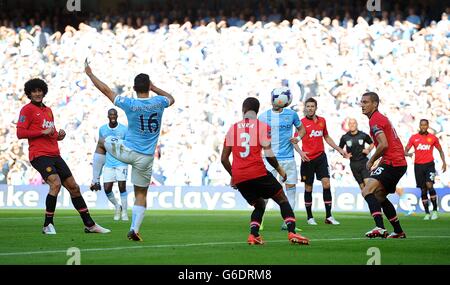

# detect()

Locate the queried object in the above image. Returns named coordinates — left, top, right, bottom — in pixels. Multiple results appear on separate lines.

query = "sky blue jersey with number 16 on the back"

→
left=114, top=96, right=169, bottom=155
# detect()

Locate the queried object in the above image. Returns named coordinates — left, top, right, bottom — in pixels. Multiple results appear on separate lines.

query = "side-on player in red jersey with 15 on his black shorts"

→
left=361, top=92, right=407, bottom=238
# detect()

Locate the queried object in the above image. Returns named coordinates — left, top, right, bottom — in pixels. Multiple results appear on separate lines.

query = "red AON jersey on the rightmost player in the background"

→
left=406, top=133, right=441, bottom=164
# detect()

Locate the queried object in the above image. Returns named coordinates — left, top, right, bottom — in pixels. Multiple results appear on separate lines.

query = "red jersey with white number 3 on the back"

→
left=224, top=118, right=270, bottom=184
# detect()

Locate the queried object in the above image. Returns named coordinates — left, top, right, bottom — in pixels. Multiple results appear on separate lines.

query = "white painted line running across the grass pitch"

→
left=0, top=236, right=450, bottom=256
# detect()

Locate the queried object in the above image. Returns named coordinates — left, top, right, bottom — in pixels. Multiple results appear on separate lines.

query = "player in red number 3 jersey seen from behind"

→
left=221, top=97, right=309, bottom=245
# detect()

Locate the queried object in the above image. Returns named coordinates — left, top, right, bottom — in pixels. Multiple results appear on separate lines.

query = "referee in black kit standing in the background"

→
left=339, top=119, right=374, bottom=190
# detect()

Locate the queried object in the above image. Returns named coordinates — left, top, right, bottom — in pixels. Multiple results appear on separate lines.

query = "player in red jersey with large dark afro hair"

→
left=17, top=79, right=110, bottom=234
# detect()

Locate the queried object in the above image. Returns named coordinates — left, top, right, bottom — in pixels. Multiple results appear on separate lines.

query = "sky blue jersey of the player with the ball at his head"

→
left=258, top=108, right=302, bottom=160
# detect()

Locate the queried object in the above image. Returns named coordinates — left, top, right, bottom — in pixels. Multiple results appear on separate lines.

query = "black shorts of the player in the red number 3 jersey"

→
left=236, top=172, right=283, bottom=206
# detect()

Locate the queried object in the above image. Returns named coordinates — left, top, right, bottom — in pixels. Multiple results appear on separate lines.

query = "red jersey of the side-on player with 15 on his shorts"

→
left=369, top=111, right=406, bottom=166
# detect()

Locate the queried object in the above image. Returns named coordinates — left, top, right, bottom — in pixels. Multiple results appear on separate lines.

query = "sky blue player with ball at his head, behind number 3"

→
left=258, top=88, right=308, bottom=230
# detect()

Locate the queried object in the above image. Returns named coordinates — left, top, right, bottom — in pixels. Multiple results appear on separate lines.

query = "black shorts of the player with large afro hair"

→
left=31, top=156, right=72, bottom=182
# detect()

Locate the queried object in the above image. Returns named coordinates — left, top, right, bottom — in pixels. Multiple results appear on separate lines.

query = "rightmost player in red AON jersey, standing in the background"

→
left=405, top=119, right=447, bottom=220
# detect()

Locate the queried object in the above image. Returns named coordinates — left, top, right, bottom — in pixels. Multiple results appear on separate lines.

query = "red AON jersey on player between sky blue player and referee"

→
left=302, top=116, right=328, bottom=160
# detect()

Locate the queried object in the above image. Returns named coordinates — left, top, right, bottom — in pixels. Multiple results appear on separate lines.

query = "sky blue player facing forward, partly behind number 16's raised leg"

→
left=91, top=108, right=128, bottom=221
